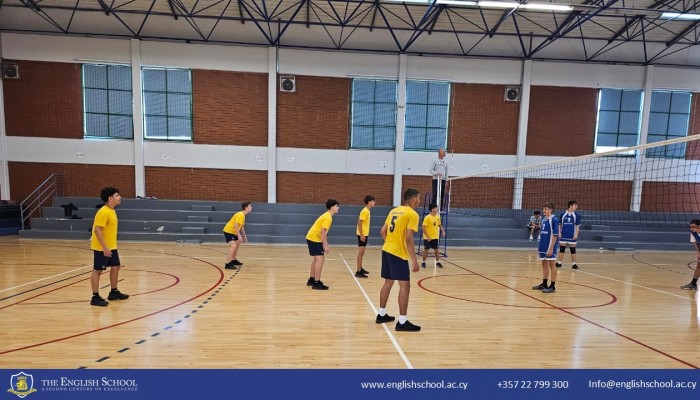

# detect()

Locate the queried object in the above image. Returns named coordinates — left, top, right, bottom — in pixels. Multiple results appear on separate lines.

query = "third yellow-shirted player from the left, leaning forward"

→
left=306, top=199, right=340, bottom=290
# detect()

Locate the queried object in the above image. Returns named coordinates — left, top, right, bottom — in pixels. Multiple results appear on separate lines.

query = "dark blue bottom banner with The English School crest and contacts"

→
left=0, top=369, right=700, bottom=400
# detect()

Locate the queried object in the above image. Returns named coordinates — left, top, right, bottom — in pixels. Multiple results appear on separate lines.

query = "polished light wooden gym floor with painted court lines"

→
left=0, top=236, right=700, bottom=369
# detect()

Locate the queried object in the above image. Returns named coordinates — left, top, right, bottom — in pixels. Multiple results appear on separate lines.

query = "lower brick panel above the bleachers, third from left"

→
left=277, top=172, right=394, bottom=206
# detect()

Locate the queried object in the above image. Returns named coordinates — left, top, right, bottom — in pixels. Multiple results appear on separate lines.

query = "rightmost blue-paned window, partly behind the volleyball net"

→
left=646, top=90, right=691, bottom=158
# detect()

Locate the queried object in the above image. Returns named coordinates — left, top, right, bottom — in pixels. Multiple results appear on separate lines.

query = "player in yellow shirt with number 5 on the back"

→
left=376, top=189, right=420, bottom=332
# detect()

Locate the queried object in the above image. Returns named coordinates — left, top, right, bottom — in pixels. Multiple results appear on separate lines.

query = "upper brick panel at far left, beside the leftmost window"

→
left=3, top=60, right=83, bottom=139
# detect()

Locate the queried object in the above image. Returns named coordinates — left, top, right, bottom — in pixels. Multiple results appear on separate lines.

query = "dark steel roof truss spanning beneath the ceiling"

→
left=0, top=0, right=700, bottom=64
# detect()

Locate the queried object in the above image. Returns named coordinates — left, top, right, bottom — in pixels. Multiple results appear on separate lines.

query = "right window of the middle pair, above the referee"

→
left=404, top=81, right=450, bottom=150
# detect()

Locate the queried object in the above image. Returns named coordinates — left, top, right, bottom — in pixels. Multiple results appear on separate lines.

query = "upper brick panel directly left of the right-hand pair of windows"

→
left=527, top=86, right=598, bottom=157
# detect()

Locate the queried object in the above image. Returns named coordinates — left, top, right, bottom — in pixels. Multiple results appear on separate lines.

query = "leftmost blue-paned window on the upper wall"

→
left=83, top=64, right=134, bottom=139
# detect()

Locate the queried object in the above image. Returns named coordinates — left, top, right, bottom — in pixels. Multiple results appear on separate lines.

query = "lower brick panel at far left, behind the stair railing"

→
left=8, top=162, right=136, bottom=201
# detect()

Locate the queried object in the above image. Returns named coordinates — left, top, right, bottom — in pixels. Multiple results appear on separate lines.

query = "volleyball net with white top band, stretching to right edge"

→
left=448, top=135, right=700, bottom=227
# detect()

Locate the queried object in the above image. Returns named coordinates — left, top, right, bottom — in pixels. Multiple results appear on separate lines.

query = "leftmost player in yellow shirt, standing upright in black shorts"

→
left=90, top=187, right=129, bottom=307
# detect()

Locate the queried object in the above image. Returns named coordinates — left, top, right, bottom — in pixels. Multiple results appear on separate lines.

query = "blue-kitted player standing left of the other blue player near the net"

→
left=532, top=203, right=559, bottom=293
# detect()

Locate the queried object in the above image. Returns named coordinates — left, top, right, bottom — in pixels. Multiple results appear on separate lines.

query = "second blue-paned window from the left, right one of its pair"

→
left=143, top=68, right=192, bottom=140
